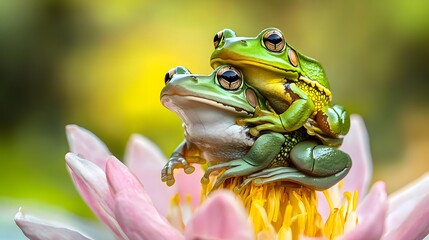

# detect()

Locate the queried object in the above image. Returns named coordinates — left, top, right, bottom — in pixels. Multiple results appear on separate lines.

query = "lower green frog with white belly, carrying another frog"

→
left=161, top=65, right=351, bottom=190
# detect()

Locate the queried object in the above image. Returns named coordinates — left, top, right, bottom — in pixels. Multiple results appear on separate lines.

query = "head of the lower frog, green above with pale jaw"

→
left=161, top=65, right=264, bottom=124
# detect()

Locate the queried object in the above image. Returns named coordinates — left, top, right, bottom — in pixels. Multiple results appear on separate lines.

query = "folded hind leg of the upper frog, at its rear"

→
left=305, top=105, right=350, bottom=139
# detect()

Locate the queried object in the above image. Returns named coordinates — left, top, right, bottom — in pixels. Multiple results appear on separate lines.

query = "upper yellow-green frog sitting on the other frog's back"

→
left=210, top=28, right=350, bottom=146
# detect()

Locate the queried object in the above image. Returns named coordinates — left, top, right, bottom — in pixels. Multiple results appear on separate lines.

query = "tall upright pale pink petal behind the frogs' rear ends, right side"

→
left=340, top=114, right=372, bottom=202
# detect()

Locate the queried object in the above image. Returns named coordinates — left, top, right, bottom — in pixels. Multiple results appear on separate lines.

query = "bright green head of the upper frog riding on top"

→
left=210, top=28, right=329, bottom=89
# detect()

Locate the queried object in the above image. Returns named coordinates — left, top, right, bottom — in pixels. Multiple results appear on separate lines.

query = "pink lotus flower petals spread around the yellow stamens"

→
left=15, top=116, right=429, bottom=240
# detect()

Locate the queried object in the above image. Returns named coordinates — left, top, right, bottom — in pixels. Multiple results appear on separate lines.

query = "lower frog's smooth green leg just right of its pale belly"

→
left=201, top=132, right=285, bottom=189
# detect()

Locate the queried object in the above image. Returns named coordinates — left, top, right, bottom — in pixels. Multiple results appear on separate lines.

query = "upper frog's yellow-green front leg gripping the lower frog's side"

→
left=238, top=84, right=314, bottom=136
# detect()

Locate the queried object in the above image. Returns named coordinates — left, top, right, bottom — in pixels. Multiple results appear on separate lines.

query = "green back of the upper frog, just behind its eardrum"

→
left=298, top=53, right=330, bottom=89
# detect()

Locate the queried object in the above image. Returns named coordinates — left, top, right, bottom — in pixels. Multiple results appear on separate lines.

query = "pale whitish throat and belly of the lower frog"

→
left=163, top=96, right=254, bottom=162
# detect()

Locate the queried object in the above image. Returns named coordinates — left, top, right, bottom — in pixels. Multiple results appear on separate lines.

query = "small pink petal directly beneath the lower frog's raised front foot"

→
left=175, top=165, right=204, bottom=208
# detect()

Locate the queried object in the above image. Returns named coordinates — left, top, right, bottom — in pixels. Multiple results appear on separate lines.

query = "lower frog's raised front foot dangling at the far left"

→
left=161, top=140, right=205, bottom=186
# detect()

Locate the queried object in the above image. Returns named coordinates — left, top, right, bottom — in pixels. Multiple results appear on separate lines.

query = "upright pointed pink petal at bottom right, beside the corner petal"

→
left=341, top=182, right=388, bottom=240
